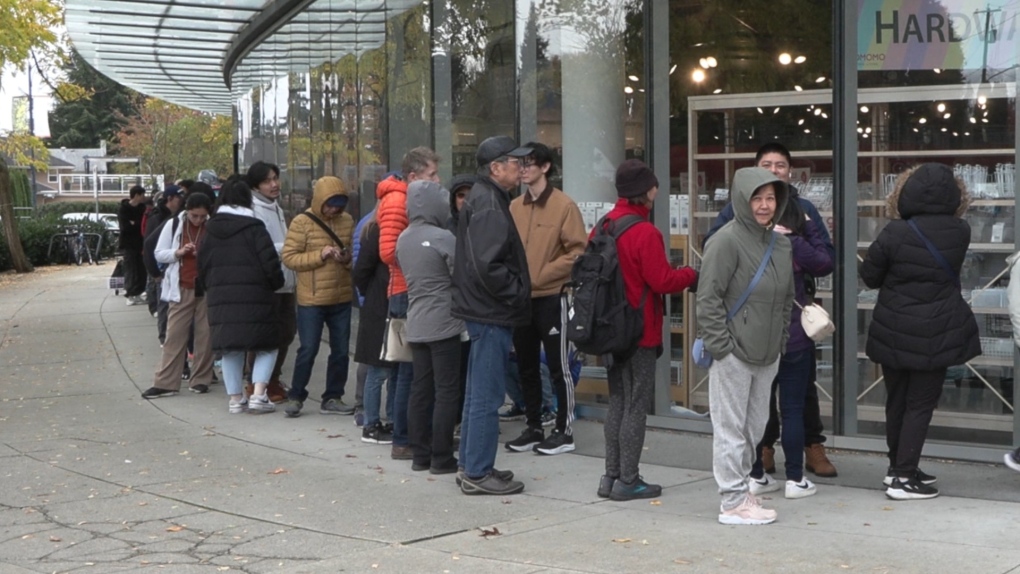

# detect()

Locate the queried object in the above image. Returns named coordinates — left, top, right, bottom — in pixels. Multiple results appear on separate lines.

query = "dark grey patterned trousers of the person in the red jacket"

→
left=604, top=347, right=656, bottom=484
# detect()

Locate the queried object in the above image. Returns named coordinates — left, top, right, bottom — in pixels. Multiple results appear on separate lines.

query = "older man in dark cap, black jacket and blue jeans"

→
left=453, top=136, right=531, bottom=494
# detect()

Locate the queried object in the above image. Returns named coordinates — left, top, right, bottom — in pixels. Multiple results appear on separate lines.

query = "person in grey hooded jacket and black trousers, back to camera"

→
left=397, top=179, right=465, bottom=474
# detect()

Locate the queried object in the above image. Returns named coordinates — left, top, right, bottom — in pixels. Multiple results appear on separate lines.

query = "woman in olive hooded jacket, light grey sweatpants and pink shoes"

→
left=697, top=167, right=796, bottom=525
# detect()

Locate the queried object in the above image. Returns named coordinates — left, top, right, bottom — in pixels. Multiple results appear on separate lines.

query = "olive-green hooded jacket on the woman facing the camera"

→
left=697, top=167, right=795, bottom=366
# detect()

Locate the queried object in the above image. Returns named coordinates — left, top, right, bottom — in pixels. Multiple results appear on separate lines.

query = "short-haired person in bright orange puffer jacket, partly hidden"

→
left=375, top=147, right=440, bottom=460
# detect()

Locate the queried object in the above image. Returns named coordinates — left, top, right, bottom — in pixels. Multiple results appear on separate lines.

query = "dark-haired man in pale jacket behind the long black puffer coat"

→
left=245, top=161, right=298, bottom=403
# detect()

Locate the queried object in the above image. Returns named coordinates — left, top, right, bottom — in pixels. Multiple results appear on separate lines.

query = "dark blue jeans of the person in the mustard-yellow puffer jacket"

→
left=287, top=303, right=351, bottom=403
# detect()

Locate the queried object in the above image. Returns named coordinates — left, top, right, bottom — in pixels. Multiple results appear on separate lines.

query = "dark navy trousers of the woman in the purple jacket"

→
left=751, top=350, right=815, bottom=482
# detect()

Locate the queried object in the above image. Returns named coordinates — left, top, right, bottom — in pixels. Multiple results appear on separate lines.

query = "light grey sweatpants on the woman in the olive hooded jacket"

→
left=708, top=353, right=779, bottom=510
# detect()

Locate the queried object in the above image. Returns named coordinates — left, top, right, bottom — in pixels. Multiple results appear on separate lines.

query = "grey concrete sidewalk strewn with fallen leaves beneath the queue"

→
left=0, top=264, right=1020, bottom=574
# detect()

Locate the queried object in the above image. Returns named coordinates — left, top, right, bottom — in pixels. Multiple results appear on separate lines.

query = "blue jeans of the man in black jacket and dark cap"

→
left=460, top=321, right=513, bottom=478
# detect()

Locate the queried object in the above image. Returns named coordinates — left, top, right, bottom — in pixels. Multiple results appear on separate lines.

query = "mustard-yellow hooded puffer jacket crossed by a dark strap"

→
left=282, top=176, right=354, bottom=307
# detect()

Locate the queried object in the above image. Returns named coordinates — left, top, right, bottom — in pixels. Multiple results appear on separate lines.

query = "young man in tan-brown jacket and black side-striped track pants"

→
left=506, top=143, right=588, bottom=455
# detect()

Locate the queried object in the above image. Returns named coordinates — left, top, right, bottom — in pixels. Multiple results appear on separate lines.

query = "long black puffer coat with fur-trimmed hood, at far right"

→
left=860, top=163, right=981, bottom=370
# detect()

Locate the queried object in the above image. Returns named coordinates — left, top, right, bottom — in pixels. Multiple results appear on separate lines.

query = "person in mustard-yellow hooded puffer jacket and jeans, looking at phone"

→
left=281, top=176, right=354, bottom=417
